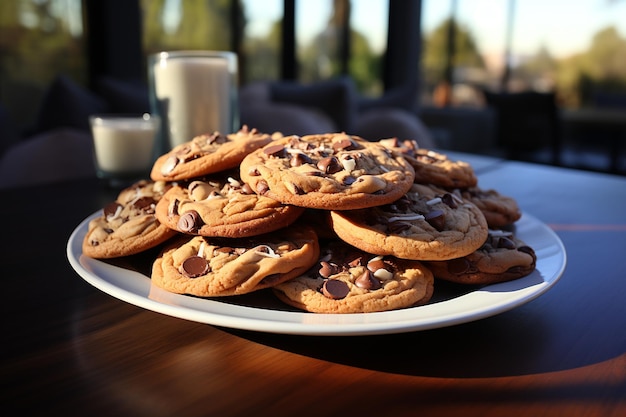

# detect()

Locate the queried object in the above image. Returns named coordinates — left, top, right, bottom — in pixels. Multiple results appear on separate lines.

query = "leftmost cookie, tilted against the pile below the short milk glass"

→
left=82, top=180, right=176, bottom=259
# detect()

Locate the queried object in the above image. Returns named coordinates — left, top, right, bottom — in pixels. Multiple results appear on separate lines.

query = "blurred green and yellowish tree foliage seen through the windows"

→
left=0, top=0, right=626, bottom=133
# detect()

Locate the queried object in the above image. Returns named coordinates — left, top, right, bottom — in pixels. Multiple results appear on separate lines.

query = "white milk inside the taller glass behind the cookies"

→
left=153, top=54, right=235, bottom=148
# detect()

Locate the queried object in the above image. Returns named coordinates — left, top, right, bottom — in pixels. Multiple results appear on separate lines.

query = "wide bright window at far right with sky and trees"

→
left=422, top=0, right=626, bottom=107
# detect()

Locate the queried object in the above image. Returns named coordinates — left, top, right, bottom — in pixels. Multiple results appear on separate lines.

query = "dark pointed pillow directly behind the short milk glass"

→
left=34, top=75, right=109, bottom=133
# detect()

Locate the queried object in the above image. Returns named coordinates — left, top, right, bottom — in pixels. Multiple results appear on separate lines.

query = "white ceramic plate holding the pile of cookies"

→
left=67, top=212, right=566, bottom=335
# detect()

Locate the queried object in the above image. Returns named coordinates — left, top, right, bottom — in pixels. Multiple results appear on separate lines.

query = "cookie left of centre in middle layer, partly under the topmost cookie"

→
left=156, top=171, right=304, bottom=237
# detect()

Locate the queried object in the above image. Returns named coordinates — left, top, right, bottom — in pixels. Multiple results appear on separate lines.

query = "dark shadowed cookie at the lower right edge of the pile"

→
left=425, top=230, right=537, bottom=285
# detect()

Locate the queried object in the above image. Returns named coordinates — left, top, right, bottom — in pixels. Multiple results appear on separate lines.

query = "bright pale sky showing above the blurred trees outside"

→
left=245, top=0, right=626, bottom=57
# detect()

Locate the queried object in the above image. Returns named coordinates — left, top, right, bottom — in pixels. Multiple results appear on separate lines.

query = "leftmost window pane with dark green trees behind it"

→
left=0, top=0, right=87, bottom=133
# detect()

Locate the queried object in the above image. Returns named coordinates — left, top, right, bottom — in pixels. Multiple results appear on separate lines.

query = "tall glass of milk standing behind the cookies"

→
left=148, top=51, right=239, bottom=154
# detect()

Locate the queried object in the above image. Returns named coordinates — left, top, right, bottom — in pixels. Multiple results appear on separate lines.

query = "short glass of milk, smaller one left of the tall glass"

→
left=89, top=113, right=160, bottom=183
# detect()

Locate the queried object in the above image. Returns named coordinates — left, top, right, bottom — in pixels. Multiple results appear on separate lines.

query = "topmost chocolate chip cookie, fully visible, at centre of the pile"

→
left=240, top=133, right=414, bottom=210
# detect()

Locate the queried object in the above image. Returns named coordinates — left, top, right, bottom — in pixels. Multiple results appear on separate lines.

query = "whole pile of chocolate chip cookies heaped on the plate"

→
left=83, top=126, right=536, bottom=313
